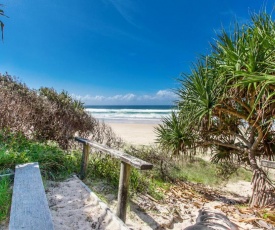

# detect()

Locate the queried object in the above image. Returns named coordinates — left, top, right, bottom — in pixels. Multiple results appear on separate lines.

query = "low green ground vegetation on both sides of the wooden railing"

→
left=0, top=132, right=251, bottom=221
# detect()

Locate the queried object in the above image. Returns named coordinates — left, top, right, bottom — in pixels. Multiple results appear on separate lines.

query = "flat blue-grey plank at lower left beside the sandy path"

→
left=9, top=162, right=54, bottom=230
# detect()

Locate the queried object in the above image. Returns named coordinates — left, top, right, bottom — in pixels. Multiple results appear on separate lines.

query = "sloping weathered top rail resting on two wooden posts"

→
left=75, top=137, right=153, bottom=170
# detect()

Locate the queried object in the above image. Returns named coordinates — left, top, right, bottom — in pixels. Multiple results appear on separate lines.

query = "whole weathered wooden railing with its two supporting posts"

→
left=75, top=137, right=153, bottom=222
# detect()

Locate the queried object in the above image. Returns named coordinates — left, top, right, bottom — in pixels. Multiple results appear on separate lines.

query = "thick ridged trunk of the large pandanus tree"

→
left=249, top=151, right=275, bottom=208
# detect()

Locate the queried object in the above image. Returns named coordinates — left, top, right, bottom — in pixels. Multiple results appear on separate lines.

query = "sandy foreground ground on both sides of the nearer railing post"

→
left=43, top=177, right=264, bottom=230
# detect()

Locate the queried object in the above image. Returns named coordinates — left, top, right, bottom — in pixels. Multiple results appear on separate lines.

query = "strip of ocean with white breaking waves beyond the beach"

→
left=85, top=105, right=173, bottom=124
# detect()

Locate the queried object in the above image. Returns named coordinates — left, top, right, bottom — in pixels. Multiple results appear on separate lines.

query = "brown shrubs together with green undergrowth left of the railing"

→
left=0, top=73, right=122, bottom=221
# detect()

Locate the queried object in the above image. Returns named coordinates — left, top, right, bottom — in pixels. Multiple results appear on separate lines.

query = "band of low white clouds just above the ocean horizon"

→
left=72, top=90, right=177, bottom=105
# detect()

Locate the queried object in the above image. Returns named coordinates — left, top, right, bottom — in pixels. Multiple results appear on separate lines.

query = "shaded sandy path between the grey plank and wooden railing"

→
left=46, top=176, right=128, bottom=230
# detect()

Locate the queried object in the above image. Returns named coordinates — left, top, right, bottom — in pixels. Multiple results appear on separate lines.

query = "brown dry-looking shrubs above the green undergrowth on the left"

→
left=0, top=74, right=121, bottom=149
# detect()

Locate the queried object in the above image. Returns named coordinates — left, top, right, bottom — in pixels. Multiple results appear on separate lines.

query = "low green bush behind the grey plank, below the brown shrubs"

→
left=0, top=133, right=81, bottom=179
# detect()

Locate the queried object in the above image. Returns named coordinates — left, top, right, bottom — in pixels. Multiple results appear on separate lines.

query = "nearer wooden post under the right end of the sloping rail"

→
left=117, top=161, right=131, bottom=222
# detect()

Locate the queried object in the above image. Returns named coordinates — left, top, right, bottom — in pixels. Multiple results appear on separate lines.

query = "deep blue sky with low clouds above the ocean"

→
left=0, top=0, right=275, bottom=105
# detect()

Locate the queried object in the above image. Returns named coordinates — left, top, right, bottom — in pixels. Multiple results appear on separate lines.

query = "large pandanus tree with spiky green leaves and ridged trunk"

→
left=157, top=12, right=275, bottom=207
